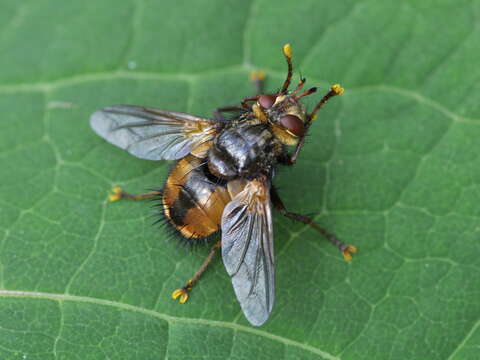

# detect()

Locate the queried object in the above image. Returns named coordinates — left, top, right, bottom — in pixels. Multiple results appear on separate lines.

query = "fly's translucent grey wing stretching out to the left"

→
left=90, top=105, right=215, bottom=160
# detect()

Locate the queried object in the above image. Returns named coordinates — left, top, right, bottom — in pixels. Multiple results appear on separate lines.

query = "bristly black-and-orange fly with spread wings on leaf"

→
left=90, top=44, right=356, bottom=326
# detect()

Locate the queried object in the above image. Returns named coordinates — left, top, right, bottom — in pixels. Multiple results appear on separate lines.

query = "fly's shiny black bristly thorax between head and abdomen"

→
left=208, top=119, right=282, bottom=179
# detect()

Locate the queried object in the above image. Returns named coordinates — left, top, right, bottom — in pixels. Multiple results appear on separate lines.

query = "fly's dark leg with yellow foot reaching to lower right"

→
left=270, top=186, right=357, bottom=261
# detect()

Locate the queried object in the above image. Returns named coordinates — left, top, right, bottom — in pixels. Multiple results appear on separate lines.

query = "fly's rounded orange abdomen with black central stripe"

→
left=163, top=155, right=231, bottom=239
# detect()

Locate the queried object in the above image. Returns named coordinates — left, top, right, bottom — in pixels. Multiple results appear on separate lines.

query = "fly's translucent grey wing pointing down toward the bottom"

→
left=222, top=180, right=275, bottom=326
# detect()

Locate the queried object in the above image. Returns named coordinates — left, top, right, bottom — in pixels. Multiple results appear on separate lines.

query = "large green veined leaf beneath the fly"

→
left=0, top=0, right=480, bottom=360
